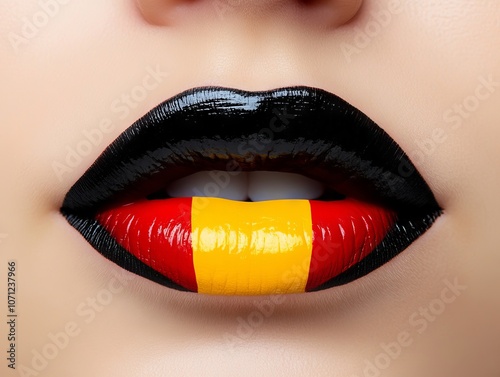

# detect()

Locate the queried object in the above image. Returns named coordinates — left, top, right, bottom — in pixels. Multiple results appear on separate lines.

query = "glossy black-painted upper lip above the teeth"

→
left=62, top=86, right=439, bottom=215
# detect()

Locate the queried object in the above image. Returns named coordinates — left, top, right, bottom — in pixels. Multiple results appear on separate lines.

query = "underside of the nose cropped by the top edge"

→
left=135, top=0, right=363, bottom=27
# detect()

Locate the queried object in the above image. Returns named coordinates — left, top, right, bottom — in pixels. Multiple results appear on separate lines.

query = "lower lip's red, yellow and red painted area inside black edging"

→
left=96, top=197, right=396, bottom=295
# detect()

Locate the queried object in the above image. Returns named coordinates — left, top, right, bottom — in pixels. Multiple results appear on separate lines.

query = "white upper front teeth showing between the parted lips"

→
left=166, top=170, right=325, bottom=202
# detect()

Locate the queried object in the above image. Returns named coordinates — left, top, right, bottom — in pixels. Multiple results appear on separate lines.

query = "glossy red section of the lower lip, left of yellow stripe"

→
left=97, top=198, right=198, bottom=292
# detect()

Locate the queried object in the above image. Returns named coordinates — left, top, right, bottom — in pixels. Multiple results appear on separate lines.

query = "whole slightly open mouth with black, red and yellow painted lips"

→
left=61, top=87, right=442, bottom=295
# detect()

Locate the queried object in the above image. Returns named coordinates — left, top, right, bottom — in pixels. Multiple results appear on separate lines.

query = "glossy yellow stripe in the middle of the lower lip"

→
left=191, top=197, right=312, bottom=295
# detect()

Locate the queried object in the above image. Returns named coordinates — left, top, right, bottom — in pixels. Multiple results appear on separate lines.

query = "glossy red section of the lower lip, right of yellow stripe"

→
left=306, top=199, right=396, bottom=292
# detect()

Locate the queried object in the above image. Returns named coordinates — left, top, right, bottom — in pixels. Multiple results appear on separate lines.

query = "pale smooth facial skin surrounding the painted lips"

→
left=0, top=0, right=500, bottom=377
